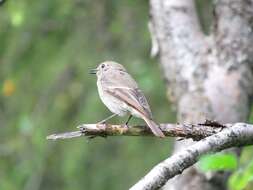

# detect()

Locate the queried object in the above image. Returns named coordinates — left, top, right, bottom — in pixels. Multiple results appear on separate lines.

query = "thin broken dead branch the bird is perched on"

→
left=47, top=121, right=225, bottom=140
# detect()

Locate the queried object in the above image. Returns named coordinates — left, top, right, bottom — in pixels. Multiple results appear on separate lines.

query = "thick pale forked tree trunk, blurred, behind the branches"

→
left=149, top=0, right=253, bottom=190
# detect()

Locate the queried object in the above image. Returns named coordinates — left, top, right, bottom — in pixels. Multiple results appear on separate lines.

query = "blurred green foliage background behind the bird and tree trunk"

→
left=0, top=0, right=253, bottom=190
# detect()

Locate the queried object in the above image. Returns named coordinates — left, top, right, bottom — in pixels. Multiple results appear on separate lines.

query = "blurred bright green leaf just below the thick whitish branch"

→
left=197, top=153, right=237, bottom=172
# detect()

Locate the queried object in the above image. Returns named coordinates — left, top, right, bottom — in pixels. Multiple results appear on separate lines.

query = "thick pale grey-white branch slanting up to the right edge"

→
left=131, top=123, right=253, bottom=190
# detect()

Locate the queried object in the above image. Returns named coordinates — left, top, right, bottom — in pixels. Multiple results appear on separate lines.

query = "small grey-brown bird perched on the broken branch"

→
left=90, top=61, right=165, bottom=137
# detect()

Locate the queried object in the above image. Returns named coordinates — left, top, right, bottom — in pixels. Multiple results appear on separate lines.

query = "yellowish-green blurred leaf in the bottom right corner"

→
left=228, top=160, right=253, bottom=190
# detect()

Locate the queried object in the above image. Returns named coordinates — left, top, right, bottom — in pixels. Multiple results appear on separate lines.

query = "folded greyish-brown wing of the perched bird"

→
left=104, top=86, right=152, bottom=119
